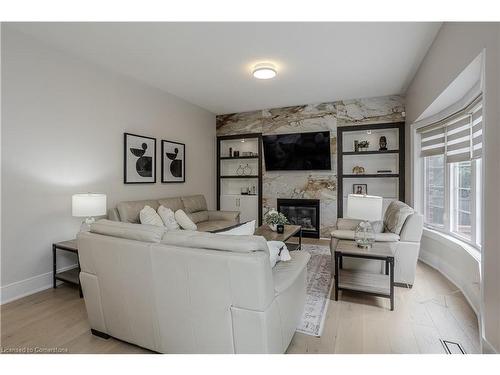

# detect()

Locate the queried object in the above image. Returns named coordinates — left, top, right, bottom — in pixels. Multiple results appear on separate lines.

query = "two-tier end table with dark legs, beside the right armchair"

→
left=334, top=240, right=396, bottom=311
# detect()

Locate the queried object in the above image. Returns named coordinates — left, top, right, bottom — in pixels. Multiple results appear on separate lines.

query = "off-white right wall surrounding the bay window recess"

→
left=406, top=23, right=500, bottom=352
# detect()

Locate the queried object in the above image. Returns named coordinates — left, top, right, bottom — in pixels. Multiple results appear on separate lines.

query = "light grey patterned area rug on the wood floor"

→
left=297, top=244, right=332, bottom=337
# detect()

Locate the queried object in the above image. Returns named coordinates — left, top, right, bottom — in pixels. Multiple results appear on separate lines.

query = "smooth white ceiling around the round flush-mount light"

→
left=10, top=22, right=441, bottom=114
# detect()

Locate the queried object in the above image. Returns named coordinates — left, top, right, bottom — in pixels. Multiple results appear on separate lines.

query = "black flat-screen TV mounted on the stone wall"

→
left=262, top=131, right=331, bottom=171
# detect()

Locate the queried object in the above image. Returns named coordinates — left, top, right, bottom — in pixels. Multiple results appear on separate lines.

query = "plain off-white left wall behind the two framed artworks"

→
left=1, top=24, right=216, bottom=302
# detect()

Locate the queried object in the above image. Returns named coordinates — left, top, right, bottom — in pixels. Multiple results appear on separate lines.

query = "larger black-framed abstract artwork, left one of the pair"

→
left=123, top=133, right=156, bottom=184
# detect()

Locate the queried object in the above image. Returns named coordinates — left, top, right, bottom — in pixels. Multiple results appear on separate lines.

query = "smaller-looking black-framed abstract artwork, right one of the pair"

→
left=161, top=140, right=186, bottom=182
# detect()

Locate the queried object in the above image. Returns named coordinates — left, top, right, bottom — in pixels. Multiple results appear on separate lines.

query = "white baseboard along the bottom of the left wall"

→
left=0, top=264, right=77, bottom=305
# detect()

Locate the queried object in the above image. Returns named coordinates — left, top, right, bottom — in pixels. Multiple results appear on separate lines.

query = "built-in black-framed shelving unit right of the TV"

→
left=337, top=122, right=405, bottom=217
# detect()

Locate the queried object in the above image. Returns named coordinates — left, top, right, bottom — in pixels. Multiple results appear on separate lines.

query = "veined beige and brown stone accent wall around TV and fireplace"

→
left=217, top=96, right=405, bottom=237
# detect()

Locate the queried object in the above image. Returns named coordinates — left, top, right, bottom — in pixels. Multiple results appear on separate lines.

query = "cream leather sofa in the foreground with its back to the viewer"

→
left=78, top=220, right=310, bottom=353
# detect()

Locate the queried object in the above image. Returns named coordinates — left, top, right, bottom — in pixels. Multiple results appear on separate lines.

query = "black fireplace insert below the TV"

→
left=278, top=198, right=319, bottom=238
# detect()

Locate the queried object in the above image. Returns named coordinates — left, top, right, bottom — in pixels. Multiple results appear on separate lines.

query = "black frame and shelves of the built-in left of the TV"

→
left=217, top=133, right=263, bottom=226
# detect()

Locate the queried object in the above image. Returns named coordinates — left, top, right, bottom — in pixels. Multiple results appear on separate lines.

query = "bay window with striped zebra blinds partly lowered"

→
left=419, top=97, right=482, bottom=248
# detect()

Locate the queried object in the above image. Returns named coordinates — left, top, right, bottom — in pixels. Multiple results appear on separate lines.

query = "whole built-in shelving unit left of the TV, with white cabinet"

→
left=217, top=133, right=262, bottom=225
